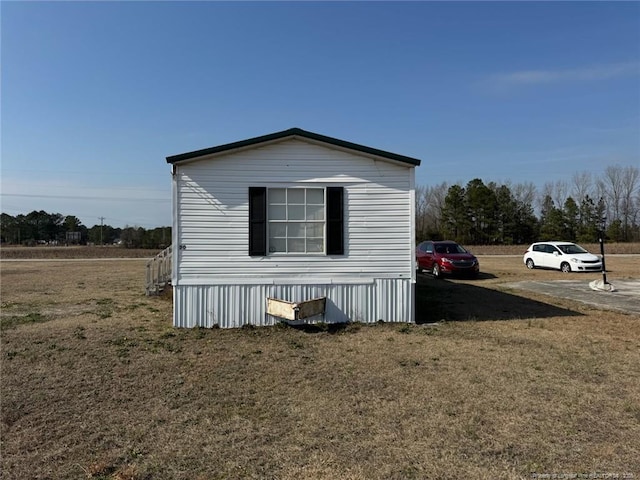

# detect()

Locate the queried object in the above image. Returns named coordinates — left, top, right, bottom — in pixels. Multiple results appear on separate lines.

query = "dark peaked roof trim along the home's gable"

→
left=167, top=128, right=420, bottom=167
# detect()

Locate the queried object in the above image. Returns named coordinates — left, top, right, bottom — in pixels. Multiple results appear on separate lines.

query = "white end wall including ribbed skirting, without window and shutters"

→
left=172, top=139, right=415, bottom=327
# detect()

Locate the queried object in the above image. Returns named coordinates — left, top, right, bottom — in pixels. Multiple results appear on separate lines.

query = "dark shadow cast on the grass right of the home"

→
left=416, top=275, right=582, bottom=324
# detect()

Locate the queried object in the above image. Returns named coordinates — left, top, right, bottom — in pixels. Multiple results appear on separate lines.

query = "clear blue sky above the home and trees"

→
left=0, top=1, right=640, bottom=228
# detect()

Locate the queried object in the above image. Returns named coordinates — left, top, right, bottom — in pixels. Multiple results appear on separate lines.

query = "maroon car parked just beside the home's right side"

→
left=416, top=240, right=480, bottom=278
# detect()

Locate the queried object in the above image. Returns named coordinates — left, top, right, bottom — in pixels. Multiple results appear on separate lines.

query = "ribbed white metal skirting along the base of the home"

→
left=173, top=279, right=415, bottom=328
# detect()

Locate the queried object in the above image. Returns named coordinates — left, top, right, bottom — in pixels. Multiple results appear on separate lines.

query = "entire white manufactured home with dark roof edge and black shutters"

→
left=166, top=128, right=420, bottom=328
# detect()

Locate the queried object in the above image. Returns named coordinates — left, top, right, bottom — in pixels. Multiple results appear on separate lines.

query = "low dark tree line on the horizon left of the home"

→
left=0, top=210, right=171, bottom=249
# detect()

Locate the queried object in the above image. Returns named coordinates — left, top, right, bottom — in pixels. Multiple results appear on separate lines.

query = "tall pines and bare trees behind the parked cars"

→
left=416, top=166, right=640, bottom=245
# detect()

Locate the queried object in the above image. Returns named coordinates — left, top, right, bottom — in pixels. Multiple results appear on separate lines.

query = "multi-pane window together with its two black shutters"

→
left=249, top=187, right=344, bottom=256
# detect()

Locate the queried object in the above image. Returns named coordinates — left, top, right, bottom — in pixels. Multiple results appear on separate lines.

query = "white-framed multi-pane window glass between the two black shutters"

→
left=267, top=188, right=325, bottom=253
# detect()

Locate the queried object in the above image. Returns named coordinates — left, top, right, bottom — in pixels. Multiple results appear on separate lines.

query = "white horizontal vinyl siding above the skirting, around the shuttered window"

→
left=174, top=140, right=414, bottom=285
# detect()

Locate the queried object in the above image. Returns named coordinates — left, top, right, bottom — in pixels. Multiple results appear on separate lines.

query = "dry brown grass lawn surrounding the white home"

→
left=0, top=256, right=640, bottom=480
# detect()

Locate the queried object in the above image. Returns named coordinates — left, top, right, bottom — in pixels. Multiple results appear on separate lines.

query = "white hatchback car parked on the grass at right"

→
left=523, top=242, right=602, bottom=273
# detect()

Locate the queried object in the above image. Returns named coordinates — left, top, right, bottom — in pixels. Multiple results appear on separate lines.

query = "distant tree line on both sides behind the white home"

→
left=0, top=166, right=640, bottom=249
